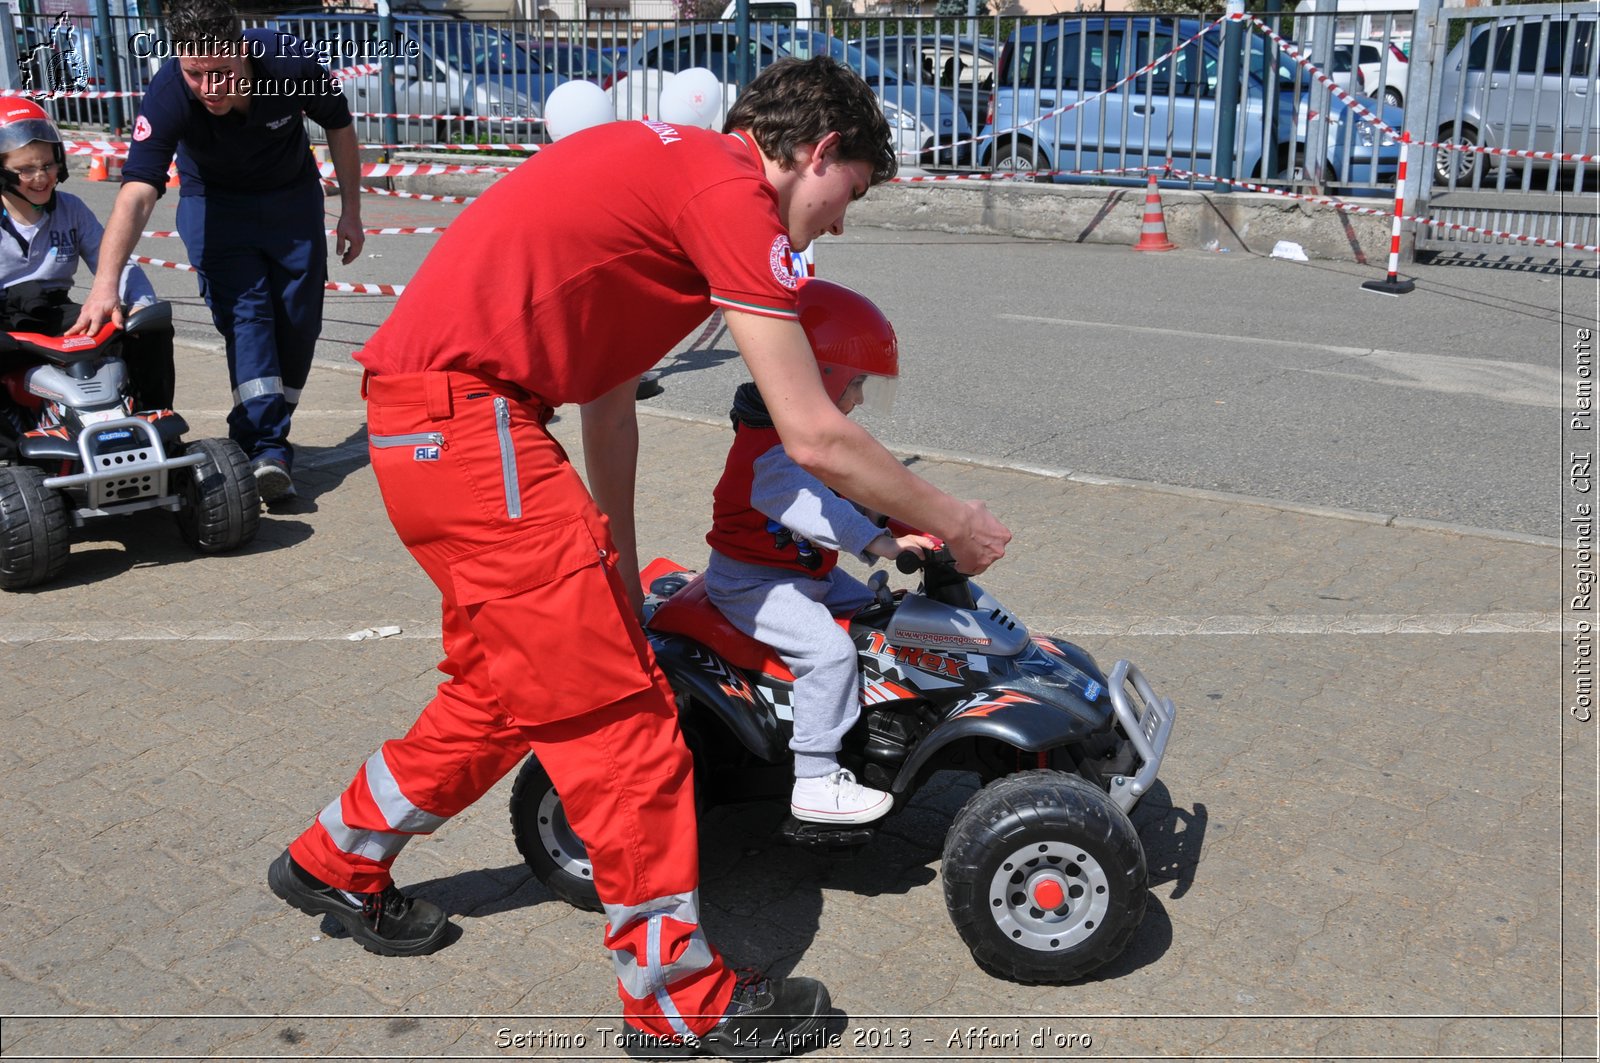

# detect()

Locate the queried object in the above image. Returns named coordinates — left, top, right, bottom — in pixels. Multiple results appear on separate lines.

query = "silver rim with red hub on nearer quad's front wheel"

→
left=989, top=842, right=1110, bottom=953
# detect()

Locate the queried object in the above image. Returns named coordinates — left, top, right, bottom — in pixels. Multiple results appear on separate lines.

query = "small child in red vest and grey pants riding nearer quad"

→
left=706, top=279, right=938, bottom=824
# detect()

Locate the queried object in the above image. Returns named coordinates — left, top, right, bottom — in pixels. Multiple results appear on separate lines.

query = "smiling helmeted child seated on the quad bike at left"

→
left=0, top=99, right=173, bottom=458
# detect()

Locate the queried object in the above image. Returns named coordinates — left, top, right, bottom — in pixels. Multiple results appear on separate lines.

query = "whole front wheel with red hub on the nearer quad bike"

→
left=944, top=770, right=1146, bottom=983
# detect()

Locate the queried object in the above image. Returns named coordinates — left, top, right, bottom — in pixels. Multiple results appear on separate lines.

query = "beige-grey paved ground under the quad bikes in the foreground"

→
left=0, top=342, right=1597, bottom=1060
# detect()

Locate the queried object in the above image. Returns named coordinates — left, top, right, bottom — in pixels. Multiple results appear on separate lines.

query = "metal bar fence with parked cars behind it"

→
left=13, top=5, right=1600, bottom=217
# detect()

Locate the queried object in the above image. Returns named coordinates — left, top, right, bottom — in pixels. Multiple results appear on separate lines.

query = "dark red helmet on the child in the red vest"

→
left=800, top=277, right=899, bottom=411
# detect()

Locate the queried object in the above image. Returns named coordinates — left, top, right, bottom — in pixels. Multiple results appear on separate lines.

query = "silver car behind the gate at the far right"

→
left=1434, top=11, right=1600, bottom=187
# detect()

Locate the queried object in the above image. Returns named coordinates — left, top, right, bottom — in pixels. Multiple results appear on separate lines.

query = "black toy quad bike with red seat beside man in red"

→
left=510, top=548, right=1176, bottom=983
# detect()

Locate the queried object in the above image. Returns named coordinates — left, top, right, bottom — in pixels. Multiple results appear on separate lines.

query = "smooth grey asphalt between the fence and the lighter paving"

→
left=69, top=171, right=1600, bottom=536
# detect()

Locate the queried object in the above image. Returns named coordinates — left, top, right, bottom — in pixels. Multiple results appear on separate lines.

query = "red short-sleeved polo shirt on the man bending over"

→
left=355, top=122, right=797, bottom=407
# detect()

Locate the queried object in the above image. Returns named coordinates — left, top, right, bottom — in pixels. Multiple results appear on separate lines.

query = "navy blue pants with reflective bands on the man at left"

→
left=178, top=181, right=328, bottom=463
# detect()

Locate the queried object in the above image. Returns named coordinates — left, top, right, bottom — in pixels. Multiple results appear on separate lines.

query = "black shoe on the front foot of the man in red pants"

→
left=622, top=972, right=830, bottom=1060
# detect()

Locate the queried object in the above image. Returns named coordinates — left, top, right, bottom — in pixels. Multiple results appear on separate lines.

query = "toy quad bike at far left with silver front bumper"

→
left=0, top=303, right=261, bottom=591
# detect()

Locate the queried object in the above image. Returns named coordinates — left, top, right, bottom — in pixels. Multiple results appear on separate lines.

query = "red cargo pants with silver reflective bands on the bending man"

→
left=290, top=373, right=734, bottom=1036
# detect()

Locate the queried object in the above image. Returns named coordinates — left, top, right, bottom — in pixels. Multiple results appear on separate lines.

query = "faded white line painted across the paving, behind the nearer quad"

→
left=0, top=613, right=1562, bottom=644
